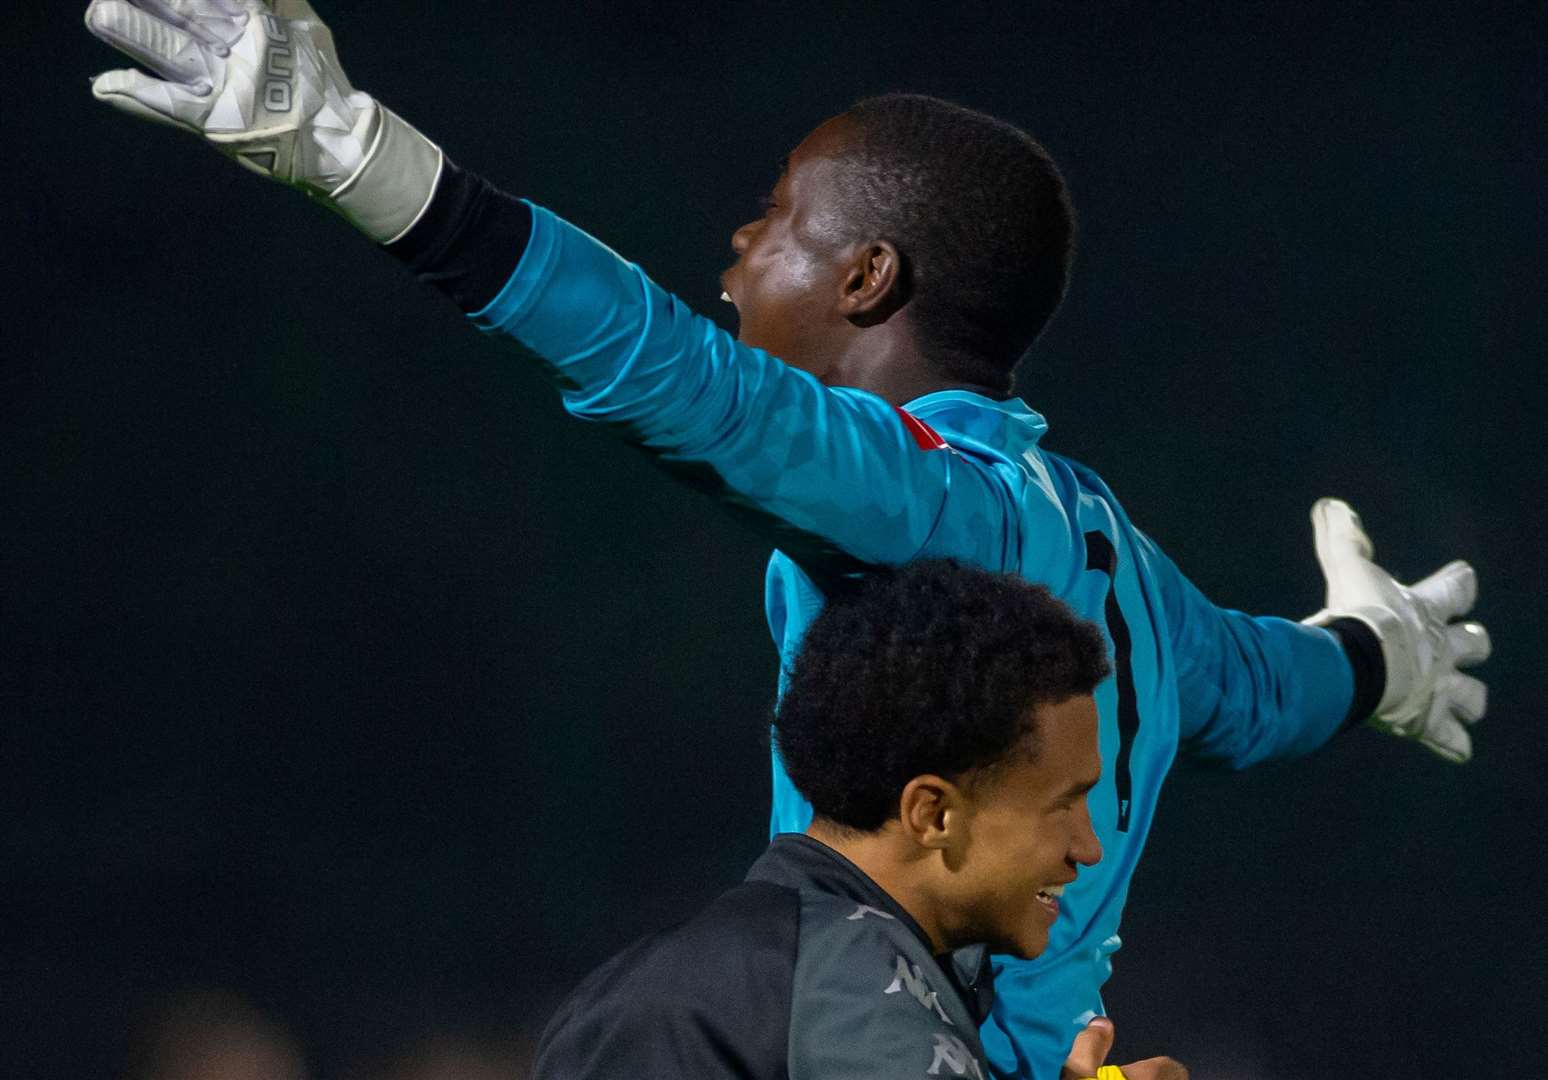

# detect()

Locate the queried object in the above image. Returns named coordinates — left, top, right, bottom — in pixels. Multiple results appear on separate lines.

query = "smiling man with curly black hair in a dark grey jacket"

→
left=534, top=560, right=1187, bottom=1080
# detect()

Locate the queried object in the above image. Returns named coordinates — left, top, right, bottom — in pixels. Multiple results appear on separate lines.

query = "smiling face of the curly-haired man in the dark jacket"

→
left=938, top=695, right=1102, bottom=958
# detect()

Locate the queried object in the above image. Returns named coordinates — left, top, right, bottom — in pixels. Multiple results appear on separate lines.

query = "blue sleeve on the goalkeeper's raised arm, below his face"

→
left=471, top=206, right=1017, bottom=569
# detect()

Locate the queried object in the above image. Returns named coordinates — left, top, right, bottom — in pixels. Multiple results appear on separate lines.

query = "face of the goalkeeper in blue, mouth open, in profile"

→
left=720, top=116, right=859, bottom=379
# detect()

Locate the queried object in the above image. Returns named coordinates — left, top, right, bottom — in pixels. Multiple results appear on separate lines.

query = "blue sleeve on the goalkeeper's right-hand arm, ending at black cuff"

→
left=1136, top=531, right=1355, bottom=769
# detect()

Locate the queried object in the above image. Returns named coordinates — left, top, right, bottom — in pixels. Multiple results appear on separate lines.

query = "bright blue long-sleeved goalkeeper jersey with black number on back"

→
left=472, top=206, right=1355, bottom=1080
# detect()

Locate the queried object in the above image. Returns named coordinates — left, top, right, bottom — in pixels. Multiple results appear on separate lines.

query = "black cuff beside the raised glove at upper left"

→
left=385, top=158, right=533, bottom=314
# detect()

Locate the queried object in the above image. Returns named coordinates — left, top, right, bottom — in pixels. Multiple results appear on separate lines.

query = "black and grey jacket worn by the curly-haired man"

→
left=533, top=834, right=992, bottom=1080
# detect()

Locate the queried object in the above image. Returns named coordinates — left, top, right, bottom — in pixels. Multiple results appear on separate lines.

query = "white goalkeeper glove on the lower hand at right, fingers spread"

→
left=1305, top=498, right=1489, bottom=764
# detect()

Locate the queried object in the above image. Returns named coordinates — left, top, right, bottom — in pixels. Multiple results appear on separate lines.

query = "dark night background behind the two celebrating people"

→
left=0, top=0, right=1548, bottom=1080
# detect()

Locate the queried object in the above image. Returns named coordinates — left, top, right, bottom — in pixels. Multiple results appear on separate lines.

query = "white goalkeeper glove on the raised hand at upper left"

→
left=87, top=0, right=441, bottom=243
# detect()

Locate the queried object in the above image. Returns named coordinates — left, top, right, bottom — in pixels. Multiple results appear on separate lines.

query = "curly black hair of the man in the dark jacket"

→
left=774, top=559, right=1111, bottom=831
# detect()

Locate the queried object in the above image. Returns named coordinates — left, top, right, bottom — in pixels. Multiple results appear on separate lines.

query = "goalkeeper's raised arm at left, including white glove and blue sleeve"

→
left=87, top=0, right=1017, bottom=569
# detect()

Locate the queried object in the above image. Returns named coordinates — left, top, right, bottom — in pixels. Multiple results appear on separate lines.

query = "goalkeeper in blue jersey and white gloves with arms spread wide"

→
left=87, top=0, right=1489, bottom=1077
